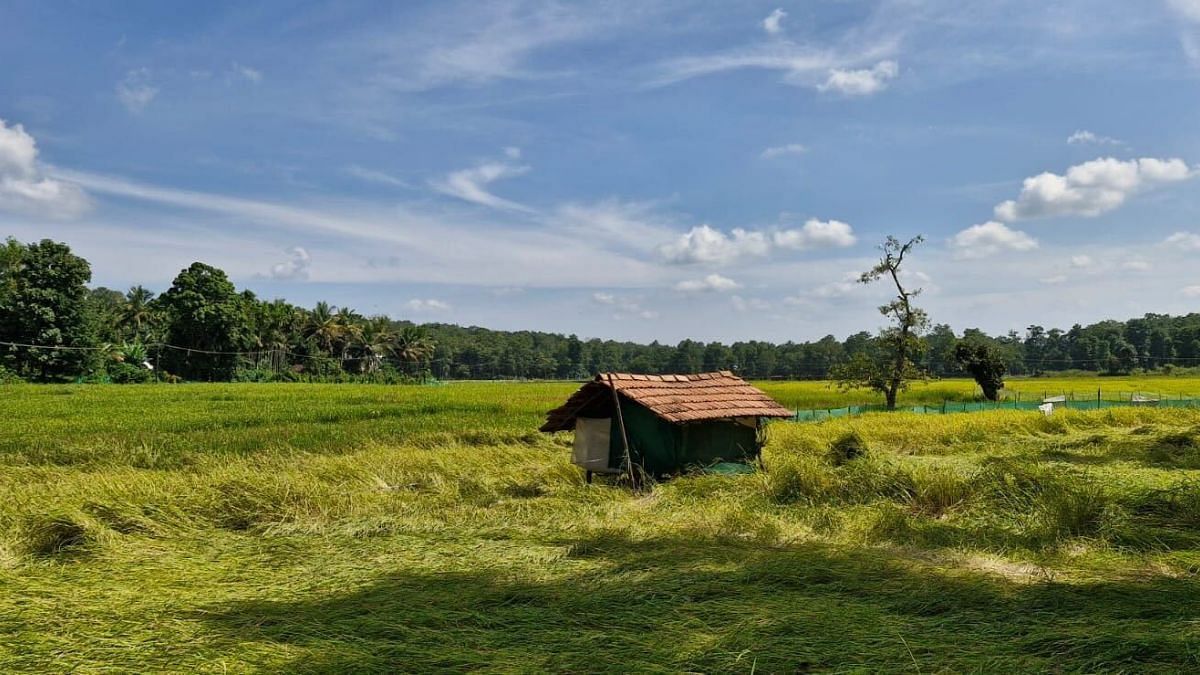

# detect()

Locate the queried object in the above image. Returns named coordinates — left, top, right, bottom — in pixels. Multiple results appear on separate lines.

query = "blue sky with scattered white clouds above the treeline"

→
left=0, top=0, right=1200, bottom=342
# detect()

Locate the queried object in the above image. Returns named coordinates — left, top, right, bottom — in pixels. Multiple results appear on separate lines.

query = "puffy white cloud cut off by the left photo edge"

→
left=0, top=119, right=90, bottom=217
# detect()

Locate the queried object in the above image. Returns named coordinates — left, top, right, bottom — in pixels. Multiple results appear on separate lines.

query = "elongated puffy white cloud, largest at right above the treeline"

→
left=995, top=157, right=1195, bottom=222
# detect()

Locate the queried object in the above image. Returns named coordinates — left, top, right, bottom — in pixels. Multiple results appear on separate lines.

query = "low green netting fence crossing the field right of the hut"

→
left=792, top=394, right=1200, bottom=422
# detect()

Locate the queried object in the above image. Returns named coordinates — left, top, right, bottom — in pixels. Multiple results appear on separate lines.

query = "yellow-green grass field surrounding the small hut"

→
left=0, top=378, right=1200, bottom=673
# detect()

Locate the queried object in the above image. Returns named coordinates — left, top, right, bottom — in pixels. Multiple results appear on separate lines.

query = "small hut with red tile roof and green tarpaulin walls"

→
left=541, top=370, right=792, bottom=479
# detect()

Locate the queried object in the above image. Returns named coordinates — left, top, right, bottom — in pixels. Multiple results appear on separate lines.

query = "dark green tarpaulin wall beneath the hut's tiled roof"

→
left=608, top=399, right=758, bottom=473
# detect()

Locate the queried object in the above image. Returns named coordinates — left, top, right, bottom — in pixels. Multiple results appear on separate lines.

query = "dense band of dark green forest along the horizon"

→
left=0, top=239, right=1200, bottom=382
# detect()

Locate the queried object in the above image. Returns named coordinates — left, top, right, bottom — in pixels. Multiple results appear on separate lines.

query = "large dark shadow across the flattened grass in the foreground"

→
left=204, top=531, right=1200, bottom=673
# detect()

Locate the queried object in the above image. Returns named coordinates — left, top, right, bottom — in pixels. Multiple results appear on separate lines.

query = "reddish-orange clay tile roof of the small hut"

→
left=541, top=370, right=792, bottom=431
